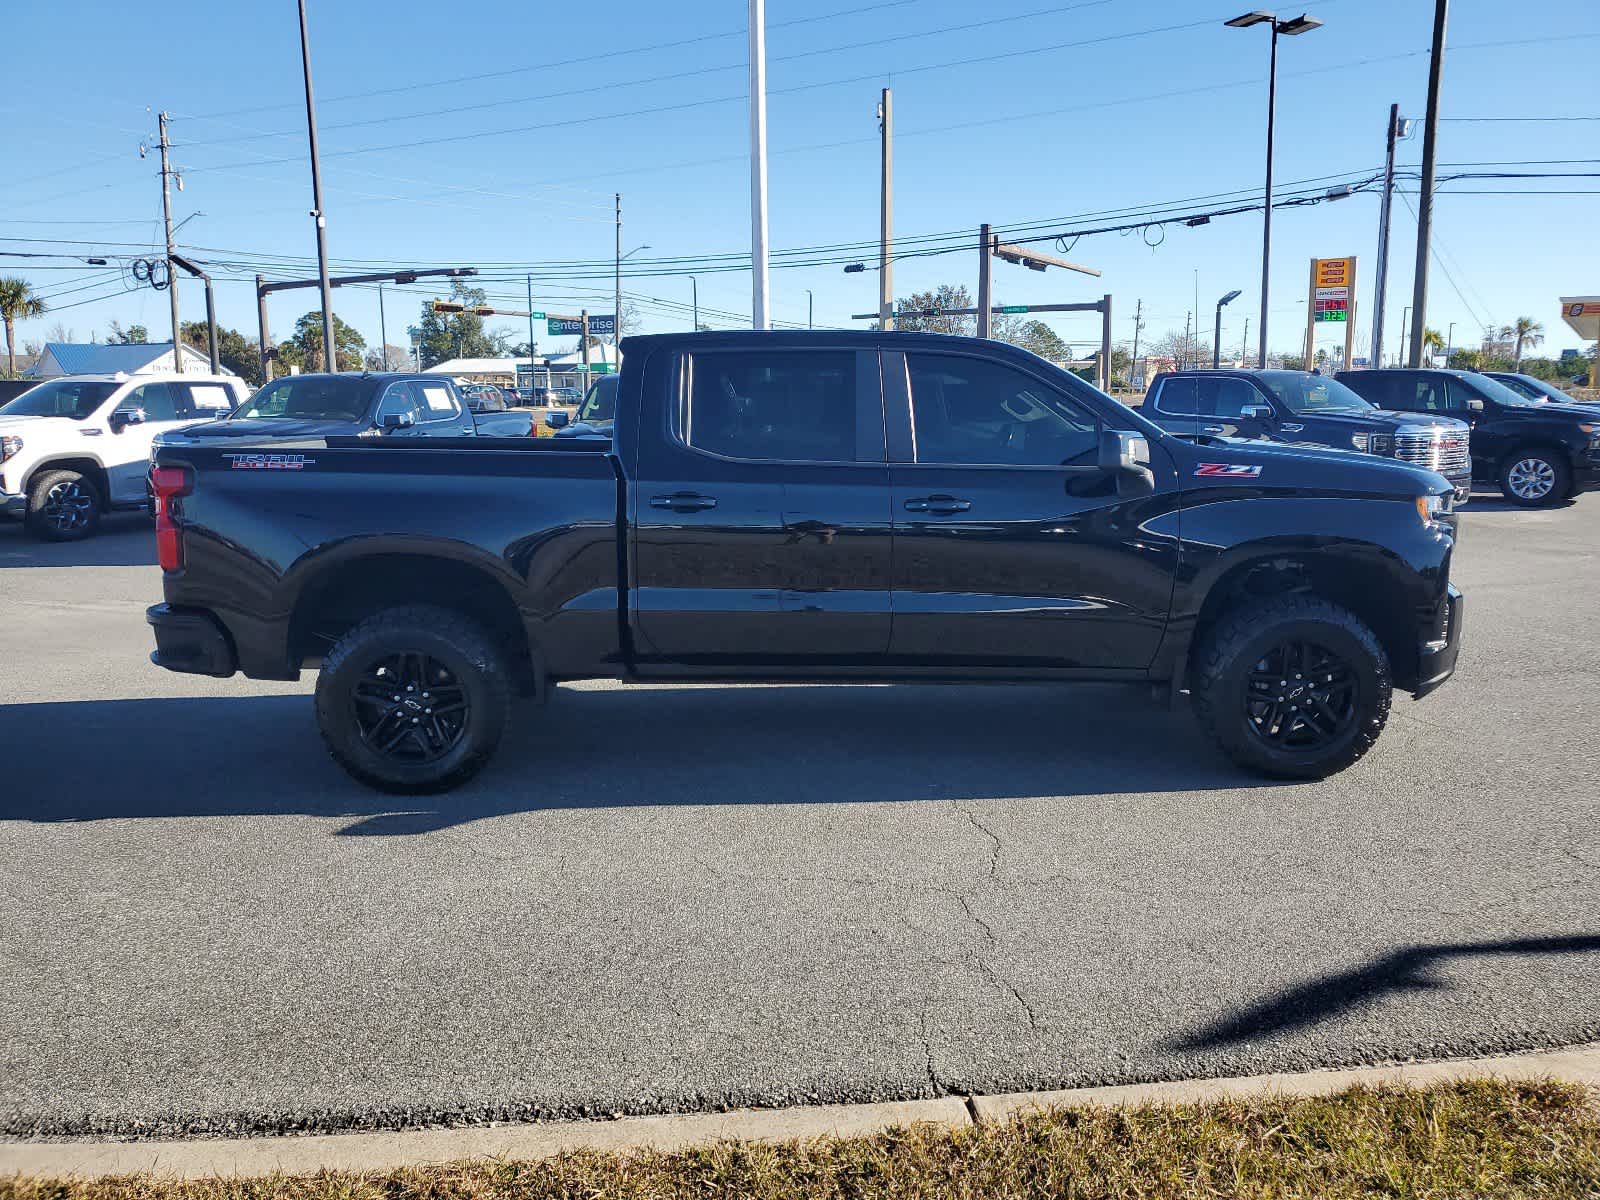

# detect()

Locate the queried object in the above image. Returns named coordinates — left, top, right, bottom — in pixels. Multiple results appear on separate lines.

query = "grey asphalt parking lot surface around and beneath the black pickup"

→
left=0, top=496, right=1600, bottom=1136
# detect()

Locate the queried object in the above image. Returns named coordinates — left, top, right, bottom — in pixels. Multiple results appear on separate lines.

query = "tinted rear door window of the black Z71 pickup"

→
left=682, top=350, right=856, bottom=462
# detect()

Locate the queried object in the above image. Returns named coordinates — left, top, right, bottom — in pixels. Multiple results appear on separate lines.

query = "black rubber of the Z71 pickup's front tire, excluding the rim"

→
left=1189, top=592, right=1392, bottom=779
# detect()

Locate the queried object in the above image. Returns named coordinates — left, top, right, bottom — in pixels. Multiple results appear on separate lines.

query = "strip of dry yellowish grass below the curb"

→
left=0, top=1082, right=1600, bottom=1200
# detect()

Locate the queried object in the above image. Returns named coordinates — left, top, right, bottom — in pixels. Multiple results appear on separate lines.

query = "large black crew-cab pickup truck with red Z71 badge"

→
left=149, top=333, right=1464, bottom=792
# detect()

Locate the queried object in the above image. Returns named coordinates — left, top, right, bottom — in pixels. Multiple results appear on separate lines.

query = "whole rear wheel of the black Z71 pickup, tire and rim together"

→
left=317, top=605, right=512, bottom=795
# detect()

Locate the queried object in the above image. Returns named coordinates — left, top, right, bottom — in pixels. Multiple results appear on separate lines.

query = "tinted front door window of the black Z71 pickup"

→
left=906, top=354, right=1100, bottom=467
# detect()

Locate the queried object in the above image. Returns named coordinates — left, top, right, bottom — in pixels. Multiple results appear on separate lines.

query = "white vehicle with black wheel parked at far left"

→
left=0, top=373, right=250, bottom=542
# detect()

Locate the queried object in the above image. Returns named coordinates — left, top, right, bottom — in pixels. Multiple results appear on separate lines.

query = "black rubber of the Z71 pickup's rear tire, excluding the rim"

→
left=317, top=605, right=512, bottom=795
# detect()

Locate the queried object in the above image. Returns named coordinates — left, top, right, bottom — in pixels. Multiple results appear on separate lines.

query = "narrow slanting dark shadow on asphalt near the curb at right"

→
left=1168, top=934, right=1600, bottom=1054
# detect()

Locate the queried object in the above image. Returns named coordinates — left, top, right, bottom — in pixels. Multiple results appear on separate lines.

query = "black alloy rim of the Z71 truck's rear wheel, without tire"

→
left=350, top=653, right=472, bottom=765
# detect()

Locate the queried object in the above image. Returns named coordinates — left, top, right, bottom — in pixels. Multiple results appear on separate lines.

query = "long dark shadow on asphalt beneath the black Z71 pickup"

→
left=0, top=685, right=1270, bottom=837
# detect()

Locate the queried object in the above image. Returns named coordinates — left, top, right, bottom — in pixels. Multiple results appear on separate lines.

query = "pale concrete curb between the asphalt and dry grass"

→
left=0, top=1043, right=1600, bottom=1179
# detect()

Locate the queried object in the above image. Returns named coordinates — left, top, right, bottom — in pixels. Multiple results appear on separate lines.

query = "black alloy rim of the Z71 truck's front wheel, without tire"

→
left=1245, top=640, right=1360, bottom=752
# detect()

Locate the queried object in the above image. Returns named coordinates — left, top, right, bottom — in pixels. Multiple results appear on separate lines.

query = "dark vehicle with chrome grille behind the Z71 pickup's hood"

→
left=1139, top=370, right=1472, bottom=501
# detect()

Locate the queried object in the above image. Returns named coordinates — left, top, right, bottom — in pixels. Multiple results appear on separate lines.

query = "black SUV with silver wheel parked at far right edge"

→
left=1336, top=370, right=1600, bottom=509
